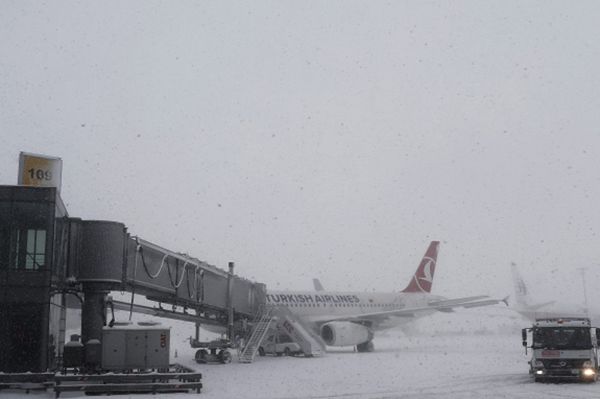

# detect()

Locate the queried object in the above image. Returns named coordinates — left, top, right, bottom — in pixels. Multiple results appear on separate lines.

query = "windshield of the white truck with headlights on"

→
left=533, top=327, right=592, bottom=349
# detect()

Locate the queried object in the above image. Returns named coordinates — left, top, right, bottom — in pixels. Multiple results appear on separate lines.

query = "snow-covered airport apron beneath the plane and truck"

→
left=0, top=310, right=600, bottom=399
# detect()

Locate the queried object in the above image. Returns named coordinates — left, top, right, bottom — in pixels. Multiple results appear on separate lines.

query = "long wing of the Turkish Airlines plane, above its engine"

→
left=316, top=295, right=506, bottom=324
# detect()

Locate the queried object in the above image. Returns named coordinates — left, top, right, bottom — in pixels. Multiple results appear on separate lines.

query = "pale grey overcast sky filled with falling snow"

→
left=0, top=0, right=600, bottom=308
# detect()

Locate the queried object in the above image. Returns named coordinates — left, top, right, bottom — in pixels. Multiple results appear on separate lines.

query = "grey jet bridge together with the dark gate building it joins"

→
left=0, top=186, right=266, bottom=372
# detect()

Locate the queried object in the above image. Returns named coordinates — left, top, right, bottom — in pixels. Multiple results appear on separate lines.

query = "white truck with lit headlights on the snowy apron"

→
left=522, top=317, right=600, bottom=382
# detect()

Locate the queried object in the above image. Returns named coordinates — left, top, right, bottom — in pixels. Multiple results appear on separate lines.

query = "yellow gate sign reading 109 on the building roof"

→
left=19, top=152, right=62, bottom=191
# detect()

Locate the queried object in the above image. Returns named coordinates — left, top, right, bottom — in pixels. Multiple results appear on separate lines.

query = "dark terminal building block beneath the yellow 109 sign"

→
left=0, top=186, right=68, bottom=372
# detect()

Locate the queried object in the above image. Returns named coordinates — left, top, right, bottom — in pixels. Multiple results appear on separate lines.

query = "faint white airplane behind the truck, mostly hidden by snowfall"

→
left=509, top=262, right=589, bottom=321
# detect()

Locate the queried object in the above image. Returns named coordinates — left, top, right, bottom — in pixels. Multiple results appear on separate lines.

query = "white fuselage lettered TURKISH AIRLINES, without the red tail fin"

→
left=267, top=291, right=443, bottom=330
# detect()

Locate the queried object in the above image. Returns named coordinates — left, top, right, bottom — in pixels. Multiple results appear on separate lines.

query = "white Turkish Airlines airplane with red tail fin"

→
left=267, top=241, right=506, bottom=352
